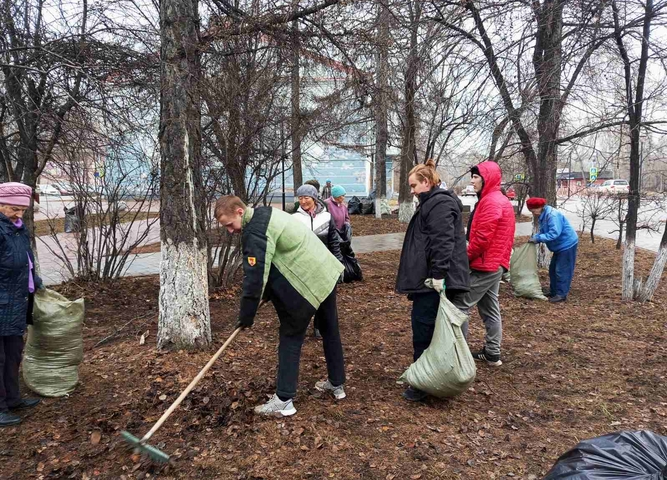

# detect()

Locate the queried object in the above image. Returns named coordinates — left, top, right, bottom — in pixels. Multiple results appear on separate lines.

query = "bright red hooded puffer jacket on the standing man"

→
left=468, top=161, right=515, bottom=272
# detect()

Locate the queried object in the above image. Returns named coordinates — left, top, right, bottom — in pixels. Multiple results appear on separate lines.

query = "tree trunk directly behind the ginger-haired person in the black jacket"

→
left=398, top=1, right=421, bottom=223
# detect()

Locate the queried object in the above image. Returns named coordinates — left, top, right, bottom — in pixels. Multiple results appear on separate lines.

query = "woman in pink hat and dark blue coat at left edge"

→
left=0, top=182, right=43, bottom=427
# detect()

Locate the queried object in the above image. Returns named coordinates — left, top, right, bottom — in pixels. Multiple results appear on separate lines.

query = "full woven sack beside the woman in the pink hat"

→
left=22, top=290, right=84, bottom=397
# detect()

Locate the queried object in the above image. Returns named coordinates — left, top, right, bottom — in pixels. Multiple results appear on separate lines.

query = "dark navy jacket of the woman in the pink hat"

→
left=0, top=213, right=42, bottom=337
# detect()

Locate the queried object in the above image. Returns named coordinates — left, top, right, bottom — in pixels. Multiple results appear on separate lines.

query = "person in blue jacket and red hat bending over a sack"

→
left=526, top=197, right=579, bottom=303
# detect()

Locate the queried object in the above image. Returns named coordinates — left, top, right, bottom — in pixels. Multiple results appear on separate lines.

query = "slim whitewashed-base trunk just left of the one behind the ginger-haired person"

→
left=374, top=2, right=389, bottom=218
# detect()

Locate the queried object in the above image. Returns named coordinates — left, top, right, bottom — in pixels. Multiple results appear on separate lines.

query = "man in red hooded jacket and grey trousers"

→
left=463, top=161, right=515, bottom=366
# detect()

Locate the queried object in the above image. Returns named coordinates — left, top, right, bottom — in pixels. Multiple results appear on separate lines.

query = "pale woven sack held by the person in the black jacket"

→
left=400, top=286, right=477, bottom=398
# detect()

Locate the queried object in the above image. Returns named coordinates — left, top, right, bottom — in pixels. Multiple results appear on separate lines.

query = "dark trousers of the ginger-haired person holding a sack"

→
left=410, top=290, right=462, bottom=361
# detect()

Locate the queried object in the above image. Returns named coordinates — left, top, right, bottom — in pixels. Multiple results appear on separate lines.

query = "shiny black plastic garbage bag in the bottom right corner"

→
left=544, top=431, right=667, bottom=480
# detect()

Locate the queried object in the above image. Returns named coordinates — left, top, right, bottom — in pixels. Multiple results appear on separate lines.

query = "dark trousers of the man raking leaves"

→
left=274, top=288, right=345, bottom=399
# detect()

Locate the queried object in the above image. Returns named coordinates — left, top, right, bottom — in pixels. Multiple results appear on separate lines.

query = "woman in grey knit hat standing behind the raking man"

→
left=293, top=185, right=344, bottom=339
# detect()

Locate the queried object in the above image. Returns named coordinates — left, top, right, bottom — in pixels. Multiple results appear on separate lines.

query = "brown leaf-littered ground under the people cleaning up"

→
left=6, top=239, right=667, bottom=480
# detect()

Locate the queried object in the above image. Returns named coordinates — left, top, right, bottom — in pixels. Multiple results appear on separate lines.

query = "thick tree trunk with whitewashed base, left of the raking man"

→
left=158, top=0, right=211, bottom=348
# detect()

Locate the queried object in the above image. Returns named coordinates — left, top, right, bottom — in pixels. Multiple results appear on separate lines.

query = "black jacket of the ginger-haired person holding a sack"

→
left=396, top=187, right=470, bottom=294
